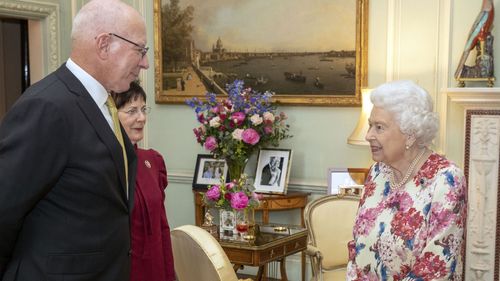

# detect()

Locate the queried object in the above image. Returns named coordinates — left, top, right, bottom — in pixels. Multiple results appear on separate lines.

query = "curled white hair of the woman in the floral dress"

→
left=370, top=80, right=439, bottom=147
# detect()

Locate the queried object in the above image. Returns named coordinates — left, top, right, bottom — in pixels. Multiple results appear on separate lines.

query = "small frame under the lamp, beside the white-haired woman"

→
left=327, top=168, right=369, bottom=195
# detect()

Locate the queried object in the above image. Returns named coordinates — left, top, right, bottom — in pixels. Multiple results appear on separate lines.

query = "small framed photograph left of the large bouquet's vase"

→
left=193, top=154, right=228, bottom=191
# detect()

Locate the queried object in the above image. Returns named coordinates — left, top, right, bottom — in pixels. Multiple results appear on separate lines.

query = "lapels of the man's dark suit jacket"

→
left=56, top=65, right=135, bottom=200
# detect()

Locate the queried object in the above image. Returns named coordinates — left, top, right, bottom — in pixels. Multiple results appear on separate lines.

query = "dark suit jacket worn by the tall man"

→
left=0, top=65, right=137, bottom=281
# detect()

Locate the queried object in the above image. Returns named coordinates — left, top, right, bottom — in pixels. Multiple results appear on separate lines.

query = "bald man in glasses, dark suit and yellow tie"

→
left=0, top=0, right=149, bottom=281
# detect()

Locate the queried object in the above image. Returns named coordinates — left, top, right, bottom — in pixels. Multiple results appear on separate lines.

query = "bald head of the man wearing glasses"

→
left=71, top=0, right=149, bottom=92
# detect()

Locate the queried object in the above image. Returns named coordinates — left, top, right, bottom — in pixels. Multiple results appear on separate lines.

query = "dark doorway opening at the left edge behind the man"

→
left=0, top=17, right=30, bottom=121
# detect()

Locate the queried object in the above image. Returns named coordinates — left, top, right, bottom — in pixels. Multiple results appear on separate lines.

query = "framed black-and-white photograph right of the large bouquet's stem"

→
left=254, top=148, right=292, bottom=194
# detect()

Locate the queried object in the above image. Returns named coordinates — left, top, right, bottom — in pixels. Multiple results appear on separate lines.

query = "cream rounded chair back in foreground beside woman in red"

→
left=171, top=225, right=251, bottom=281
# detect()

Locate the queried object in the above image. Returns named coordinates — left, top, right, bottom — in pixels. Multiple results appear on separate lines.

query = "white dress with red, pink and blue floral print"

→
left=347, top=153, right=467, bottom=281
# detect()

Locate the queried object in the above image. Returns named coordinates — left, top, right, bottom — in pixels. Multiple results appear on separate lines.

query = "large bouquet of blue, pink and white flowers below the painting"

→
left=186, top=80, right=291, bottom=180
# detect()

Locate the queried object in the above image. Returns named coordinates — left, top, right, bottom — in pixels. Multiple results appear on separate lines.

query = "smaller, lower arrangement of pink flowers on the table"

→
left=204, top=175, right=261, bottom=210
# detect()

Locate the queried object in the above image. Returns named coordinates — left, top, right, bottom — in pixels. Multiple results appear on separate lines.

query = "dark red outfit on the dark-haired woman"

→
left=130, top=148, right=175, bottom=281
